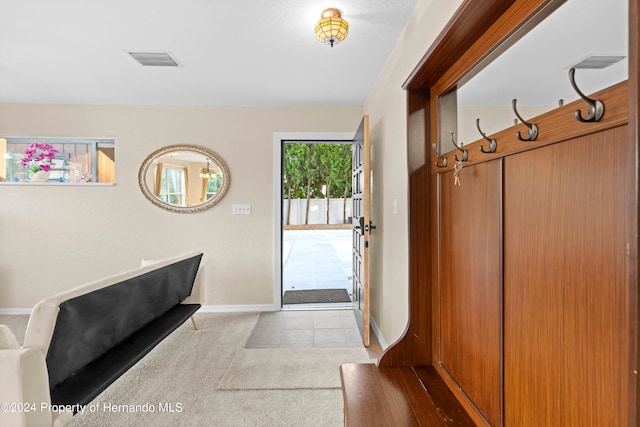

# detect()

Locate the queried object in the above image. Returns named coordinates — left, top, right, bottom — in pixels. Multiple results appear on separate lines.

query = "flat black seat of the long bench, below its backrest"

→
left=51, top=304, right=200, bottom=405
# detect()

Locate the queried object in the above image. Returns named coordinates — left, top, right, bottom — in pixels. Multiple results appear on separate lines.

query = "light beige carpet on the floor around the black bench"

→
left=0, top=313, right=368, bottom=427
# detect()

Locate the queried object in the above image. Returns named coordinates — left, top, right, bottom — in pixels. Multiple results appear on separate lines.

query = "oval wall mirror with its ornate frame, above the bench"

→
left=138, top=145, right=231, bottom=213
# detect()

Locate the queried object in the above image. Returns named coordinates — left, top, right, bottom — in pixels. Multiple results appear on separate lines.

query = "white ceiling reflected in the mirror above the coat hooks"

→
left=458, top=0, right=629, bottom=106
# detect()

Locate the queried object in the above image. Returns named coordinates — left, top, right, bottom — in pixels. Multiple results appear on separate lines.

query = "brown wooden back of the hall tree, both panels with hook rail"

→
left=431, top=84, right=637, bottom=426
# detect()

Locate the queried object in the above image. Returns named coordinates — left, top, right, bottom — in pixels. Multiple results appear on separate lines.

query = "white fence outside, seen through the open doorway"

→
left=282, top=197, right=351, bottom=225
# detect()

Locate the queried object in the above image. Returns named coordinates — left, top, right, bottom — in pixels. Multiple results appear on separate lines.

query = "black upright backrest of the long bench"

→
left=47, top=254, right=202, bottom=390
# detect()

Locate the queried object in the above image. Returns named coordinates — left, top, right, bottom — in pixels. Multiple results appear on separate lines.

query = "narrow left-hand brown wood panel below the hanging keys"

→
left=437, top=160, right=502, bottom=425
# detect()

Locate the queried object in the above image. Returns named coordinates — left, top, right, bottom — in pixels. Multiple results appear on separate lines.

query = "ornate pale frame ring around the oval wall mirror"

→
left=138, top=144, right=231, bottom=213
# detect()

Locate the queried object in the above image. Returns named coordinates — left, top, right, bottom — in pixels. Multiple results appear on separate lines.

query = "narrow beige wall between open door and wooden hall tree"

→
left=364, top=0, right=462, bottom=344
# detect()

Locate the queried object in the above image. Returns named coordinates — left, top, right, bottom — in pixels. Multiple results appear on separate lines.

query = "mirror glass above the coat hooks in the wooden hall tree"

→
left=438, top=0, right=628, bottom=147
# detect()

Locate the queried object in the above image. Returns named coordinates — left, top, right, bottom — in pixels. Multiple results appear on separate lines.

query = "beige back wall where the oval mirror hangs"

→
left=0, top=104, right=362, bottom=308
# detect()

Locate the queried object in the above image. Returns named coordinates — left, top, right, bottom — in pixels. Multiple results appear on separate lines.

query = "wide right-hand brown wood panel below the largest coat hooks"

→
left=504, top=126, right=631, bottom=426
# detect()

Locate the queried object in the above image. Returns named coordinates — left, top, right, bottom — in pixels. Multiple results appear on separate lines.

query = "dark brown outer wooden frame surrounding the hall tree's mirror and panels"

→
left=378, top=0, right=640, bottom=421
